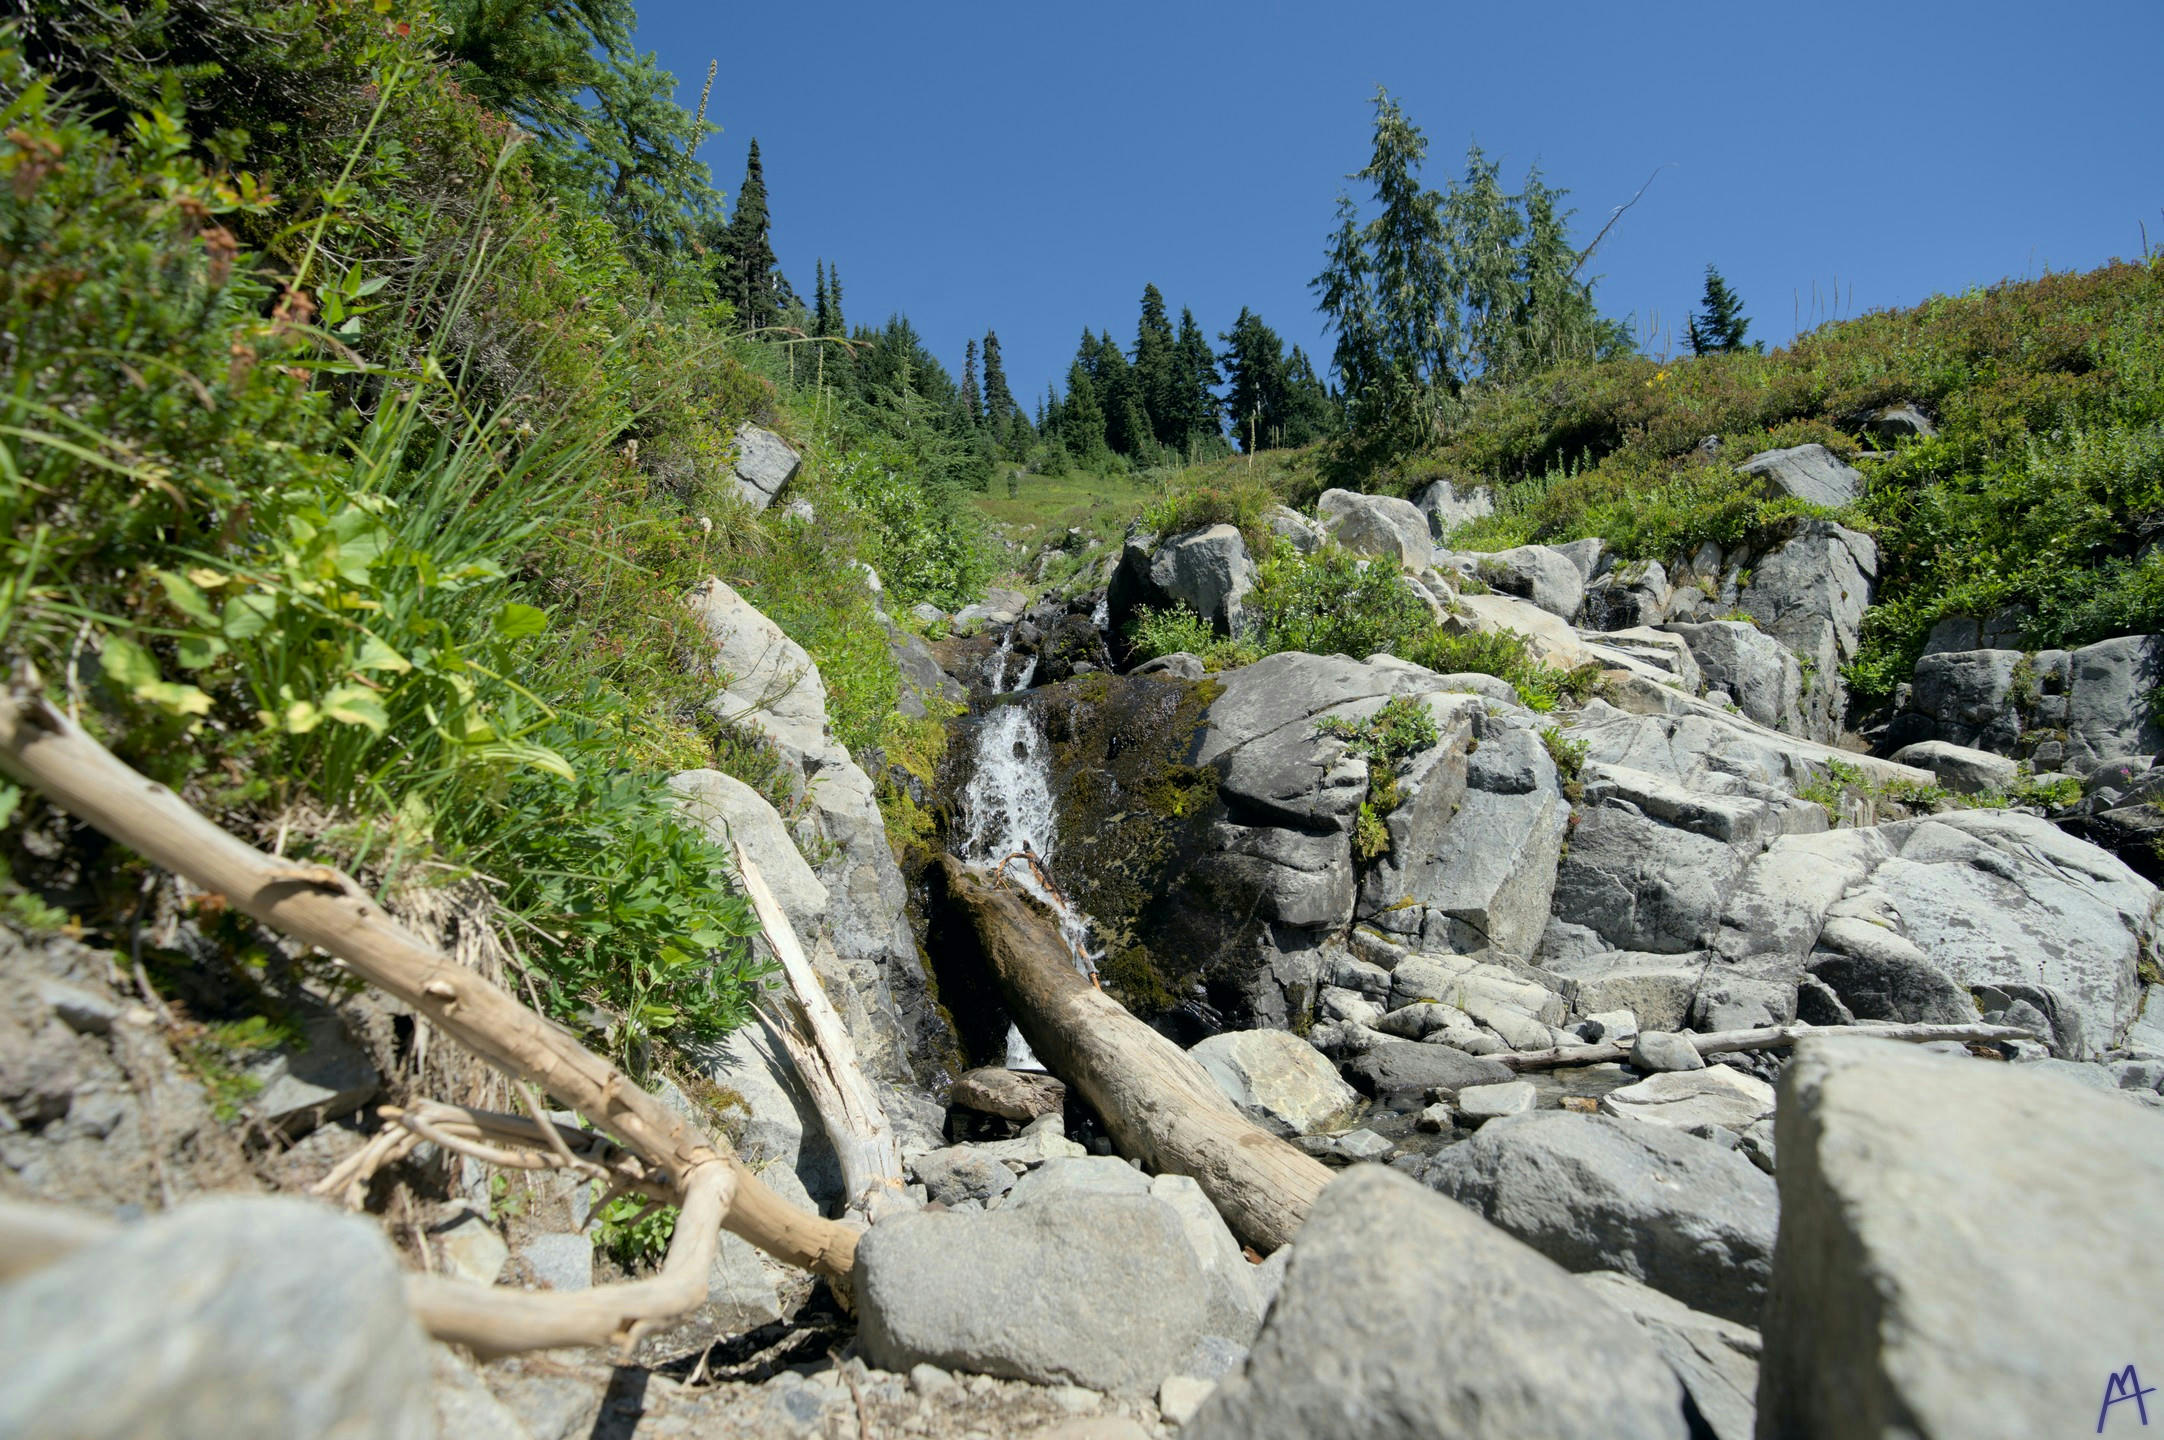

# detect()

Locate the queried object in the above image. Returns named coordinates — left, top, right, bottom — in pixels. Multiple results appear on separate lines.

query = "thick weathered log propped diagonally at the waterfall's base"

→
left=933, top=855, right=1331, bottom=1249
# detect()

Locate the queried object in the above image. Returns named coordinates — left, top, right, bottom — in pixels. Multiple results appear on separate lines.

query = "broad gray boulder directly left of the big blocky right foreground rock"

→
left=1422, top=1108, right=1779, bottom=1323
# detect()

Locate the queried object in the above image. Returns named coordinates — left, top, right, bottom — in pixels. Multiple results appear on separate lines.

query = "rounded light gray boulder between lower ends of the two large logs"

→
left=855, top=1193, right=1205, bottom=1395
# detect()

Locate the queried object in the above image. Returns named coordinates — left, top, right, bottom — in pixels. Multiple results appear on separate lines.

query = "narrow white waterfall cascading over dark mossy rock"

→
left=961, top=634, right=1097, bottom=1070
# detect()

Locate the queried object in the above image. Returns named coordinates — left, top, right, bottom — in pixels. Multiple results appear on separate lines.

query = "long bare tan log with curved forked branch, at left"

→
left=0, top=669, right=857, bottom=1349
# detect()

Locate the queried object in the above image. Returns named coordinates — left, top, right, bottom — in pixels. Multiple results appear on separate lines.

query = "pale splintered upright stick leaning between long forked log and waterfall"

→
left=731, top=842, right=902, bottom=1206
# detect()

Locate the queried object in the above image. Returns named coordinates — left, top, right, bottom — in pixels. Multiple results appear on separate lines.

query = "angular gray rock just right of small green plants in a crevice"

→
left=1359, top=712, right=1569, bottom=959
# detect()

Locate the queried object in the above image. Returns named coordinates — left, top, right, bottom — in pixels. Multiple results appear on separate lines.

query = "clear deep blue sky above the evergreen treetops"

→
left=638, top=0, right=2164, bottom=405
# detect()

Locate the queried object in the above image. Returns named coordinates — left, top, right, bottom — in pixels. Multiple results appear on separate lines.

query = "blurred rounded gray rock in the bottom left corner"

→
left=0, top=1197, right=433, bottom=1440
